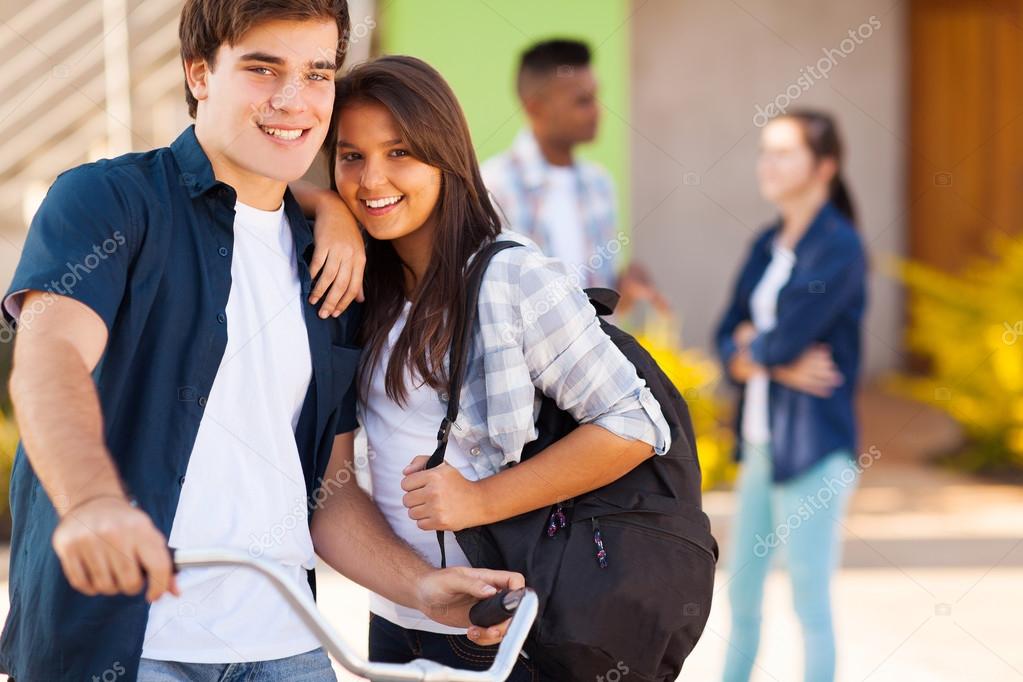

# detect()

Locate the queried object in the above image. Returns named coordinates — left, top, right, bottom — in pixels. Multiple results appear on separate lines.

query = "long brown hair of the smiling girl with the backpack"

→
left=324, top=56, right=500, bottom=405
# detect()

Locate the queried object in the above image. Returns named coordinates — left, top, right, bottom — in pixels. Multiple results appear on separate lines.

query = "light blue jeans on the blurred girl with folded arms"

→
left=723, top=446, right=859, bottom=682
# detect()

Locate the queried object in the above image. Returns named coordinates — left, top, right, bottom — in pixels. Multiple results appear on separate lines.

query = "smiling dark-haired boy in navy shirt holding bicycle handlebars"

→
left=0, top=0, right=522, bottom=681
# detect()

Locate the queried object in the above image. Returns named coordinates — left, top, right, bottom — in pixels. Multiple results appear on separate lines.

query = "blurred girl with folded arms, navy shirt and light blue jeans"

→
left=715, top=110, right=865, bottom=682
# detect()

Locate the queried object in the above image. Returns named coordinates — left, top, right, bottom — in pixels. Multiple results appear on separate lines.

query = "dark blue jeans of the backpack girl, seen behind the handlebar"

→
left=369, top=613, right=542, bottom=682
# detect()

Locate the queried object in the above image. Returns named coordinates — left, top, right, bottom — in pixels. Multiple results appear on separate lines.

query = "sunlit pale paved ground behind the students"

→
left=0, top=384, right=1023, bottom=682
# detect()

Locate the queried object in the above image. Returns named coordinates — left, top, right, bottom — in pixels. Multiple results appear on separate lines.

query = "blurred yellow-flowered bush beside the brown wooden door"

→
left=891, top=237, right=1023, bottom=470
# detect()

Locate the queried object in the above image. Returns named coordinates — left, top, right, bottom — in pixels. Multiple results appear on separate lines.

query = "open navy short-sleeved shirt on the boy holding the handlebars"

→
left=0, top=128, right=359, bottom=681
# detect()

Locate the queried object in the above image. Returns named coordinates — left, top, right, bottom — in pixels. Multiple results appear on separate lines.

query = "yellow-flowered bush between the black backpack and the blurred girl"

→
left=635, top=321, right=736, bottom=490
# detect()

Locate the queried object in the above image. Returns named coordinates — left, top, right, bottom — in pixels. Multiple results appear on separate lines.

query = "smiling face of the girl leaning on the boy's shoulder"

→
left=335, top=101, right=442, bottom=240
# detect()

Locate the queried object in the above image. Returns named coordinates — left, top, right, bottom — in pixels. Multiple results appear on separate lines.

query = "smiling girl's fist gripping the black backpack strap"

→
left=401, top=455, right=484, bottom=531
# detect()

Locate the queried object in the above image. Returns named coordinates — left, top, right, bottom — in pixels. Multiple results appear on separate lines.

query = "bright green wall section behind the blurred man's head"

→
left=377, top=0, right=630, bottom=230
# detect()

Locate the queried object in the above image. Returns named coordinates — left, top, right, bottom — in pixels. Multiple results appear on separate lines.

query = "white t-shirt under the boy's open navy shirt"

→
left=142, top=203, right=319, bottom=664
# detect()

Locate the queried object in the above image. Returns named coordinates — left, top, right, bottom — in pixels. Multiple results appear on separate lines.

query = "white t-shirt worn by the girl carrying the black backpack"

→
left=359, top=302, right=478, bottom=635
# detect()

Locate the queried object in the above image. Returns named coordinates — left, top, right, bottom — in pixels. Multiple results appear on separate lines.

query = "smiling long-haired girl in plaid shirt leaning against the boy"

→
left=319, top=56, right=670, bottom=680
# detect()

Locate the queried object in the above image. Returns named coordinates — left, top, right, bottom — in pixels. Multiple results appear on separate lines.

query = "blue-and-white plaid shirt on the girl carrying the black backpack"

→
left=440, top=231, right=671, bottom=478
